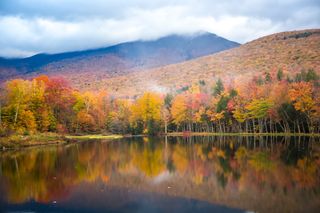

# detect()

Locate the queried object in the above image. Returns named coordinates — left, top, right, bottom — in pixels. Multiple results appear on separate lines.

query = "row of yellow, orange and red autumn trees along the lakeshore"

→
left=0, top=69, right=320, bottom=136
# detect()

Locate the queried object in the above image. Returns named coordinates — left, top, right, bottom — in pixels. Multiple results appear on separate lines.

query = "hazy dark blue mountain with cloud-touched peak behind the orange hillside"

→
left=0, top=32, right=239, bottom=80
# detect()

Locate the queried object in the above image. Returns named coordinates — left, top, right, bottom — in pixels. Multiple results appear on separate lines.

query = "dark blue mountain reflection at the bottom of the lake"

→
left=6, top=187, right=244, bottom=213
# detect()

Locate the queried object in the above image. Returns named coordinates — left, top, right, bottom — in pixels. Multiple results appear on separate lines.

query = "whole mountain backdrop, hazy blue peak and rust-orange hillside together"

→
left=0, top=29, right=320, bottom=96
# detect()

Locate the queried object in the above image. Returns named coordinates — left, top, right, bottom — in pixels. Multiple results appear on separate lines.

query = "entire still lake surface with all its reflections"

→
left=0, top=137, right=320, bottom=212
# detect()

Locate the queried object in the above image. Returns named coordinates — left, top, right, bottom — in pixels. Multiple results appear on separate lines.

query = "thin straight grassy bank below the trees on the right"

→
left=167, top=132, right=320, bottom=137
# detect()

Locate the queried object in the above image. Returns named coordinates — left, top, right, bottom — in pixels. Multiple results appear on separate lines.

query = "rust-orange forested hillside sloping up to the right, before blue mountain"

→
left=89, top=29, right=320, bottom=95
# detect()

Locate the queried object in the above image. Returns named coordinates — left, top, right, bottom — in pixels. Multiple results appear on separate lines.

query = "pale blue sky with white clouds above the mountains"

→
left=0, top=0, right=320, bottom=57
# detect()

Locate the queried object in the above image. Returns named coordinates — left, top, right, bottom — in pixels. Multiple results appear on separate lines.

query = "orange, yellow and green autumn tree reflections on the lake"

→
left=0, top=137, right=320, bottom=212
